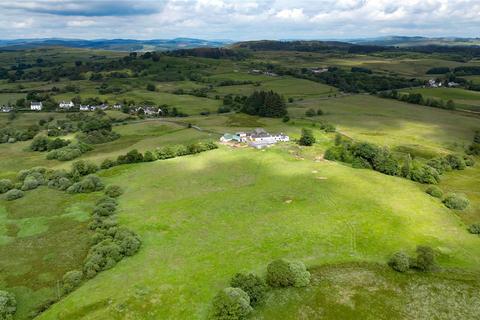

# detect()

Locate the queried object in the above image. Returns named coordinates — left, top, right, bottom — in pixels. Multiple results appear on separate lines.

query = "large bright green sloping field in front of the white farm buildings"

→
left=36, top=146, right=480, bottom=319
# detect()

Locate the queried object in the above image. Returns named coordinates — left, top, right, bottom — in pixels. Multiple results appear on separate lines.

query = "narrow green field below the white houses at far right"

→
left=402, top=88, right=480, bottom=111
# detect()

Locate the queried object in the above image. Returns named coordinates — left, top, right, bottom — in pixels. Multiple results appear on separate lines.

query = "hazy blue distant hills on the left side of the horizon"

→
left=0, top=38, right=232, bottom=51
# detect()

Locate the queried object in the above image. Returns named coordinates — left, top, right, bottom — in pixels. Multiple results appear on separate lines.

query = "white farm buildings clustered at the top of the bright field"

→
left=220, top=128, right=290, bottom=149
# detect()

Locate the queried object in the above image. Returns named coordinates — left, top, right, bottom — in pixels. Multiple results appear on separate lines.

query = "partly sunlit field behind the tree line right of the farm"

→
left=290, top=95, right=480, bottom=152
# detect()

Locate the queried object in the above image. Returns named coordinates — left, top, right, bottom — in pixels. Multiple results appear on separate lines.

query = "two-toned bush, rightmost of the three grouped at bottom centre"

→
left=267, top=259, right=310, bottom=287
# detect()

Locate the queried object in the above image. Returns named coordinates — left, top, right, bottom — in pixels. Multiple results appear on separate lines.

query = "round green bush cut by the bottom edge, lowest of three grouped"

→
left=212, top=288, right=253, bottom=320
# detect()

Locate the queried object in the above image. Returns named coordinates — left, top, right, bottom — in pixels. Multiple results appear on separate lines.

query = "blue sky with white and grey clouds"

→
left=0, top=0, right=480, bottom=40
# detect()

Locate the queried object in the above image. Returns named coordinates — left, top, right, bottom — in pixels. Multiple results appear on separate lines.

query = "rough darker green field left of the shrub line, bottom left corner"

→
left=0, top=187, right=97, bottom=319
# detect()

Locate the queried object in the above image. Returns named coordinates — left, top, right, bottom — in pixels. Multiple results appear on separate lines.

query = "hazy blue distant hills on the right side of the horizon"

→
left=346, top=36, right=480, bottom=47
